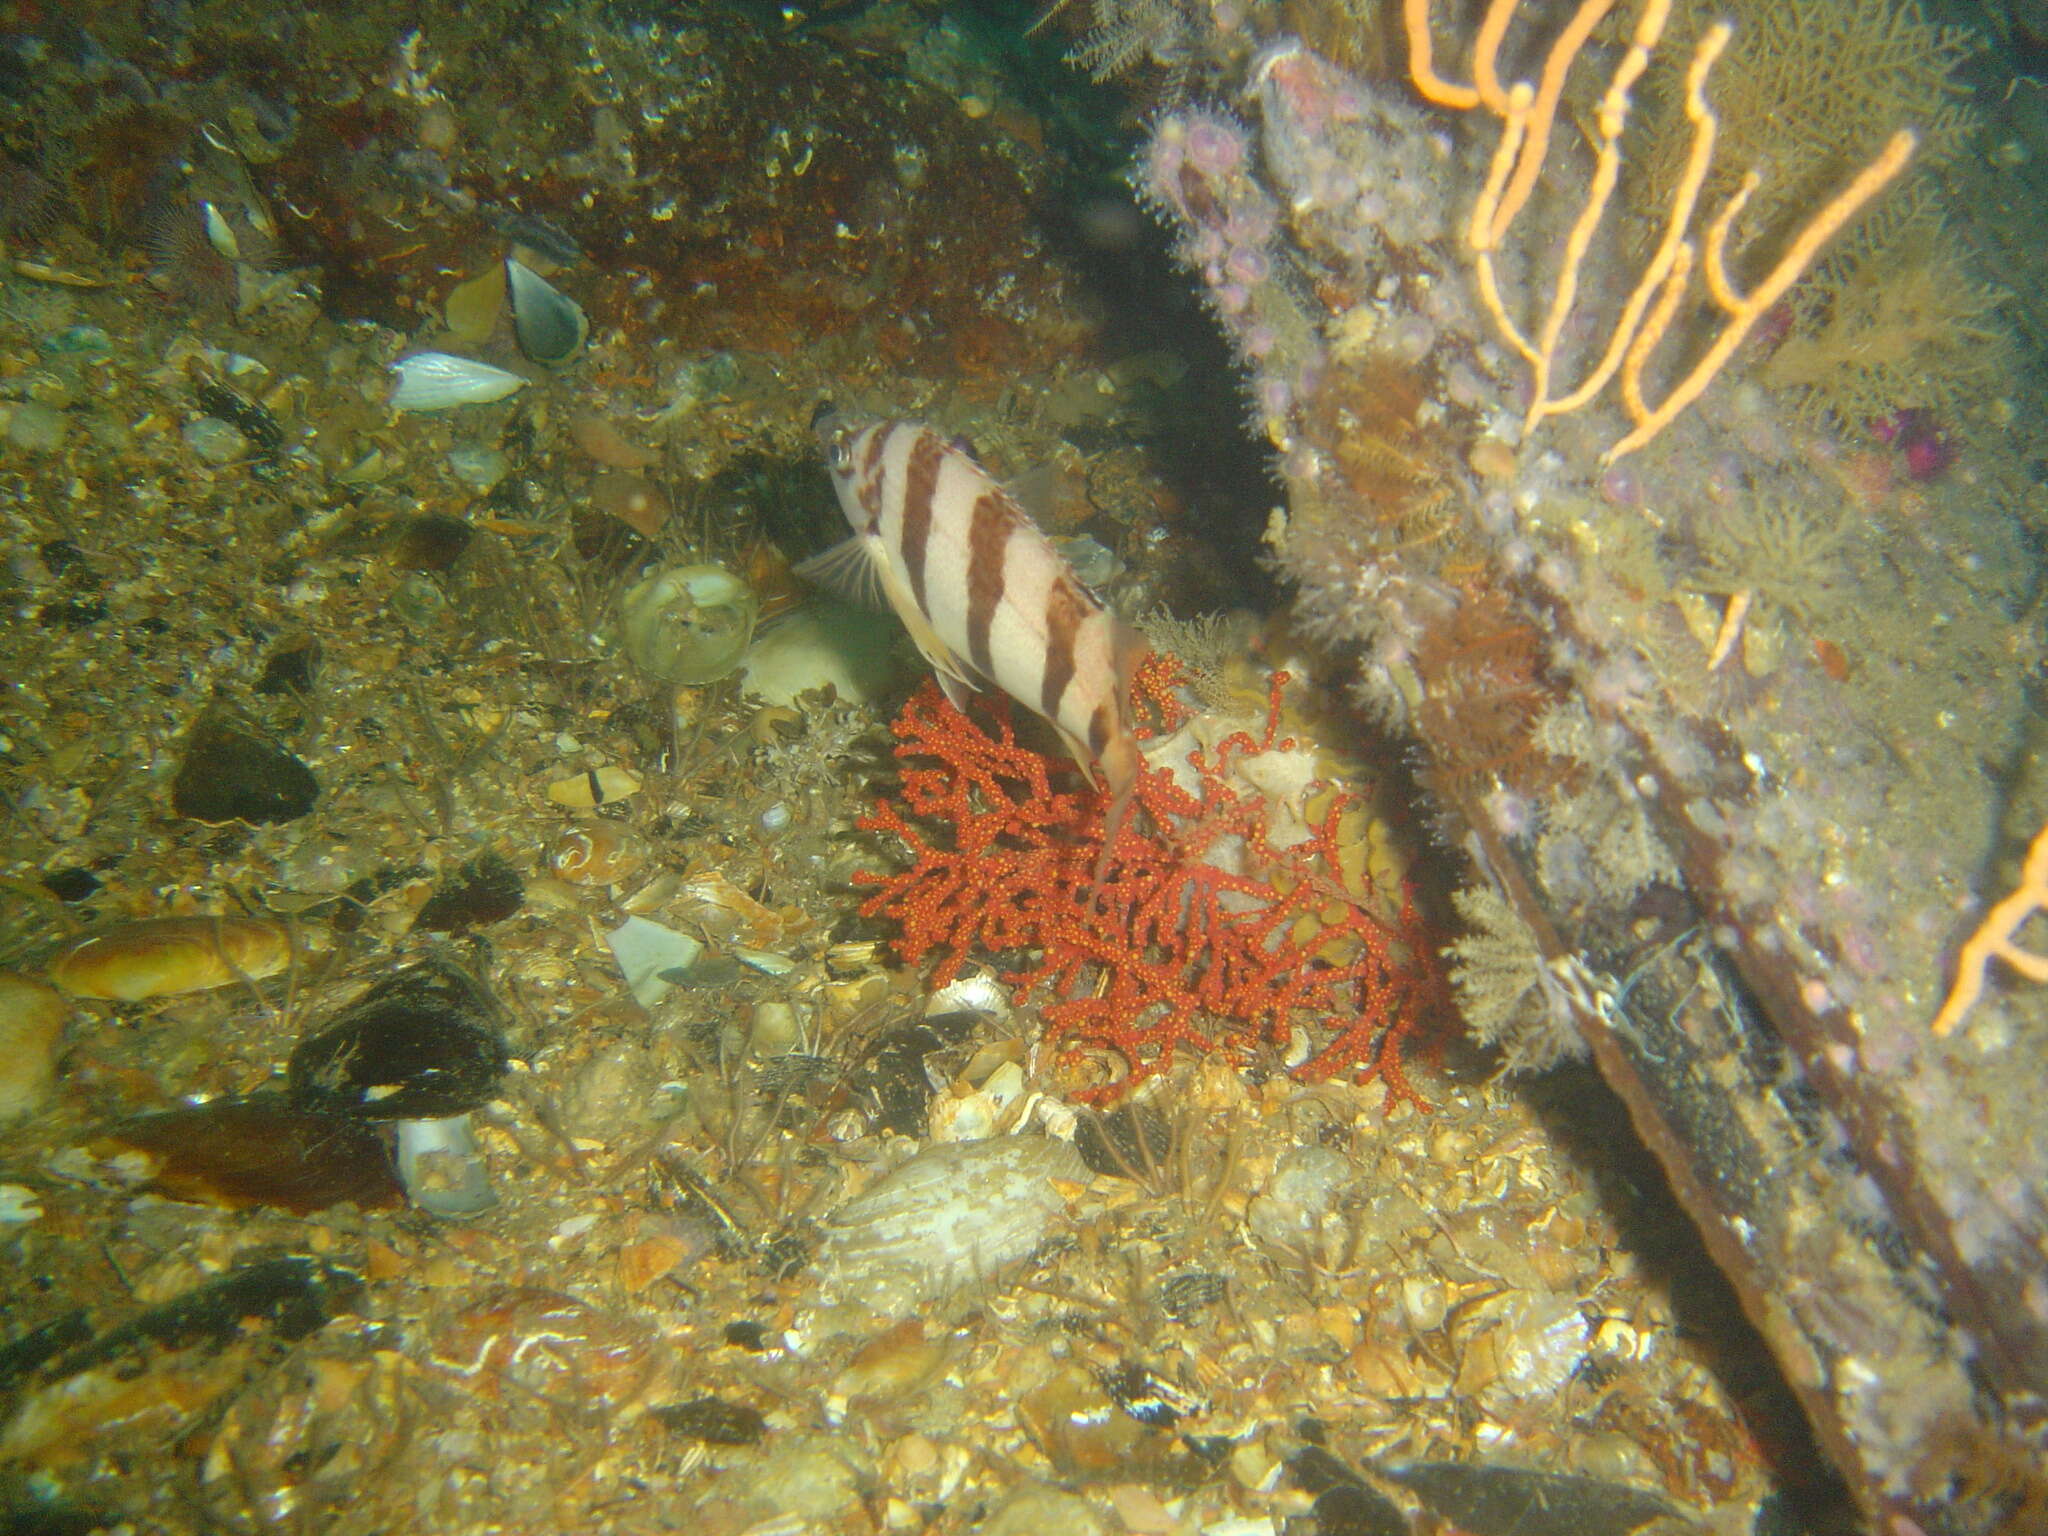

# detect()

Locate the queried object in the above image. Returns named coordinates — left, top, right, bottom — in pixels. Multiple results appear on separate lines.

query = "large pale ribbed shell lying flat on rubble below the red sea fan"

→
left=817, top=1137, right=1087, bottom=1317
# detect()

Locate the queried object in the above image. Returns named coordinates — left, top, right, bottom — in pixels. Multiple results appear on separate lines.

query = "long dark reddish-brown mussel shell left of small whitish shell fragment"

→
left=96, top=1094, right=406, bottom=1217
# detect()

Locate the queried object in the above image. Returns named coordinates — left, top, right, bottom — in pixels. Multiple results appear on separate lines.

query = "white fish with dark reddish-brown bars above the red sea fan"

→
left=797, top=414, right=1145, bottom=885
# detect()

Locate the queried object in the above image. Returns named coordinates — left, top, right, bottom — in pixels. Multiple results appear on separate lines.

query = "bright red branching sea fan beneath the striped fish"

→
left=860, top=664, right=1452, bottom=1108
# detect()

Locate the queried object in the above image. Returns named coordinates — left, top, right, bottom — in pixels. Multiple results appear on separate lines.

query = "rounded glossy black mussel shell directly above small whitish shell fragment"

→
left=287, top=965, right=506, bottom=1120
